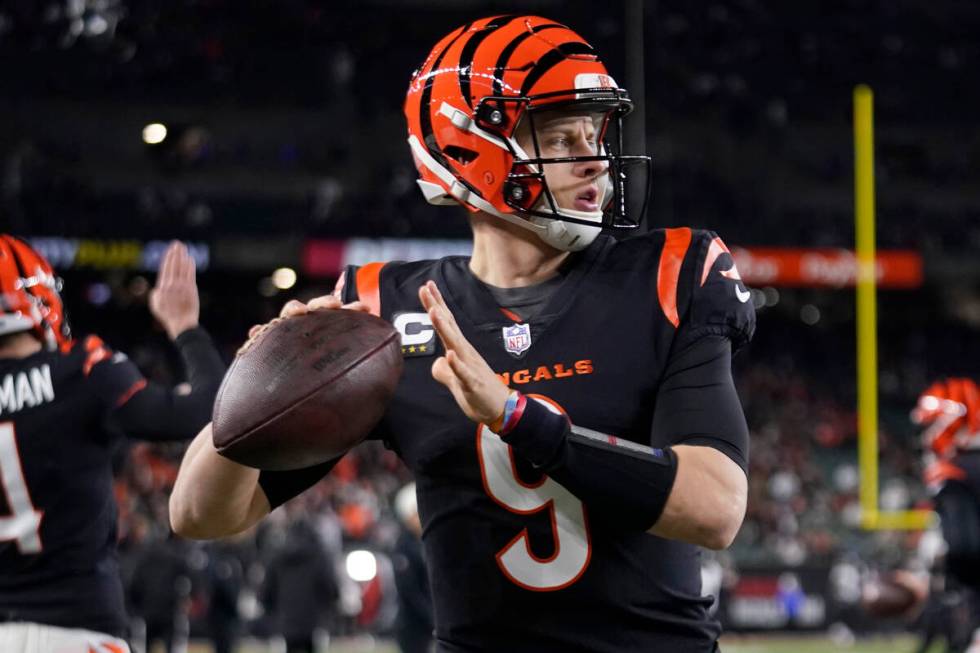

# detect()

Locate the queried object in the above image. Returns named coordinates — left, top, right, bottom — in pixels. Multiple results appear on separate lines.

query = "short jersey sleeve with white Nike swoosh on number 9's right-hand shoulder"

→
left=673, top=231, right=755, bottom=354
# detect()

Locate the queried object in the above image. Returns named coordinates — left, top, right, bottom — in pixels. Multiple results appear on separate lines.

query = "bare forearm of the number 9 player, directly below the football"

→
left=170, top=424, right=269, bottom=539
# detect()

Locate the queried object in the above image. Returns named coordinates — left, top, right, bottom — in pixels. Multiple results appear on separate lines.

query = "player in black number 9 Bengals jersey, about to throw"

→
left=171, top=16, right=755, bottom=653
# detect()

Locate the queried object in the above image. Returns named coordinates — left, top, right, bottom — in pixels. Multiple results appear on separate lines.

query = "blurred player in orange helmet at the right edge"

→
left=912, top=378, right=980, bottom=653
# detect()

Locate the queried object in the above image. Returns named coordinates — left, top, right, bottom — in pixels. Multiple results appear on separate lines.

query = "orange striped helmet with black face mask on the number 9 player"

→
left=405, top=16, right=650, bottom=251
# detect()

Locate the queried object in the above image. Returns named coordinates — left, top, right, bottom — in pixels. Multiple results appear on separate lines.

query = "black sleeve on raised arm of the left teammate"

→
left=112, top=327, right=225, bottom=440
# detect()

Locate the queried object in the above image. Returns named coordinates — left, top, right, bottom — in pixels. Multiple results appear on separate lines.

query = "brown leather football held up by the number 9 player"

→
left=212, top=309, right=402, bottom=470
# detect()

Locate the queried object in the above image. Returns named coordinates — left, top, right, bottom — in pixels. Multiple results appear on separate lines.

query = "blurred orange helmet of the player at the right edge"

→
left=912, top=378, right=980, bottom=459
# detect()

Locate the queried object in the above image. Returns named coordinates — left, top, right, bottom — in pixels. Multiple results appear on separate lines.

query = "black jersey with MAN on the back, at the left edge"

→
left=0, top=336, right=147, bottom=635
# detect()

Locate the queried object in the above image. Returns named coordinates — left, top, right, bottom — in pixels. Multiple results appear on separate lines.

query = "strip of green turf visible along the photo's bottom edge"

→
left=188, top=637, right=942, bottom=653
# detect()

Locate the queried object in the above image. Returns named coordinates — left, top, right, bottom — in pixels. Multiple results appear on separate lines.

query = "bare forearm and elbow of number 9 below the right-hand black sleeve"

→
left=650, top=445, right=748, bottom=549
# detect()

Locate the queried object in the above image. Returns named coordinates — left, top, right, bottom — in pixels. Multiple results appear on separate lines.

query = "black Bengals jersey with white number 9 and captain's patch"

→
left=260, top=228, right=755, bottom=653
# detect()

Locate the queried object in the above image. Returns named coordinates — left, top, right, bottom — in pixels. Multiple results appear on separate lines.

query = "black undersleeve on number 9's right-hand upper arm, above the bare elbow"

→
left=650, top=335, right=749, bottom=473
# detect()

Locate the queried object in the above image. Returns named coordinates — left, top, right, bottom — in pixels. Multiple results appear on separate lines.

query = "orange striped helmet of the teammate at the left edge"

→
left=0, top=234, right=71, bottom=350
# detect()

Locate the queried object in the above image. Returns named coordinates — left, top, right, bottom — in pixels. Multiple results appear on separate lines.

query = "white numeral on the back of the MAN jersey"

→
left=0, top=422, right=44, bottom=553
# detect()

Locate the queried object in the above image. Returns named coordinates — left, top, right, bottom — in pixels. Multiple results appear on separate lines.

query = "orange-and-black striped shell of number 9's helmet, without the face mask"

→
left=405, top=15, right=632, bottom=234
